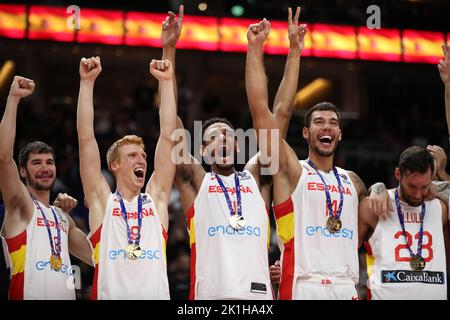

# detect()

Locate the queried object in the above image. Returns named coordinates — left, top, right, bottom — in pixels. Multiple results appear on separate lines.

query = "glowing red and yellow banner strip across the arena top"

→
left=0, top=4, right=450, bottom=63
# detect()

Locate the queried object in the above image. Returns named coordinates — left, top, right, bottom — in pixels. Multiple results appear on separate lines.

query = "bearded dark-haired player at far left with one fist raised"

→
left=0, top=76, right=92, bottom=300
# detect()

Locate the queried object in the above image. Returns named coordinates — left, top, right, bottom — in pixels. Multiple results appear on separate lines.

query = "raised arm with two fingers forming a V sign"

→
left=273, top=7, right=308, bottom=139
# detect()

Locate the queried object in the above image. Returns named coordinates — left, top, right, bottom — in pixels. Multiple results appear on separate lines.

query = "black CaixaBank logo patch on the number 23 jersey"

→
left=381, top=270, right=445, bottom=284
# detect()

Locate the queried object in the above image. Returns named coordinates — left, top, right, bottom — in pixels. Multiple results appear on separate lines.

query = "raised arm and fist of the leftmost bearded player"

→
left=0, top=76, right=35, bottom=237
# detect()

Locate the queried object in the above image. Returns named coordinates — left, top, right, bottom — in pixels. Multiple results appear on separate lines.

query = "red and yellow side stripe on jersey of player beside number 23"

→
left=273, top=198, right=295, bottom=300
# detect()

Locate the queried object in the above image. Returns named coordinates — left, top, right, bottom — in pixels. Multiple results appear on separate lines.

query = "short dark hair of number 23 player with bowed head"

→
left=398, top=146, right=434, bottom=175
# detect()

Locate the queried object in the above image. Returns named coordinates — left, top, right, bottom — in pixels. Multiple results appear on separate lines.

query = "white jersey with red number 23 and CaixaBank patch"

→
left=365, top=190, right=447, bottom=300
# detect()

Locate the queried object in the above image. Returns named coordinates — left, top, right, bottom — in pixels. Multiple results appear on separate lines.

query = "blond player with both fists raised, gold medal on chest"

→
left=77, top=57, right=176, bottom=300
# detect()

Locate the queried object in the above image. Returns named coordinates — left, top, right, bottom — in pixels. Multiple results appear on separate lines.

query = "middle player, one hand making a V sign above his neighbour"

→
left=161, top=6, right=306, bottom=299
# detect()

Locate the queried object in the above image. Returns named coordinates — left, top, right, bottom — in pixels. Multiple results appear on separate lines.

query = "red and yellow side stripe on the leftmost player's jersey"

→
left=6, top=230, right=27, bottom=300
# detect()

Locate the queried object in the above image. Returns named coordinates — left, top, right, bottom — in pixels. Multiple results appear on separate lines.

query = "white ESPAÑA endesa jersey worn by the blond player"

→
left=89, top=194, right=170, bottom=300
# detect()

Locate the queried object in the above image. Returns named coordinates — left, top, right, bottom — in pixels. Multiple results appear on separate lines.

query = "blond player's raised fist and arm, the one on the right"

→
left=146, top=60, right=177, bottom=230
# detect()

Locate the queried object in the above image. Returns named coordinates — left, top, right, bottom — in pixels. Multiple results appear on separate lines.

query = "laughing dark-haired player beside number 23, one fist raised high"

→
left=246, top=19, right=366, bottom=299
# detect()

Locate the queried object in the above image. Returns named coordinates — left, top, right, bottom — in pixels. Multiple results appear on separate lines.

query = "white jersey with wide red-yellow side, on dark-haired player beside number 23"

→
left=274, top=160, right=359, bottom=300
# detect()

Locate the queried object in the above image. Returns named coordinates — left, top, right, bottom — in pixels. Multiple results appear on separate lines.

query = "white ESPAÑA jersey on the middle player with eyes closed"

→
left=187, top=171, right=273, bottom=300
